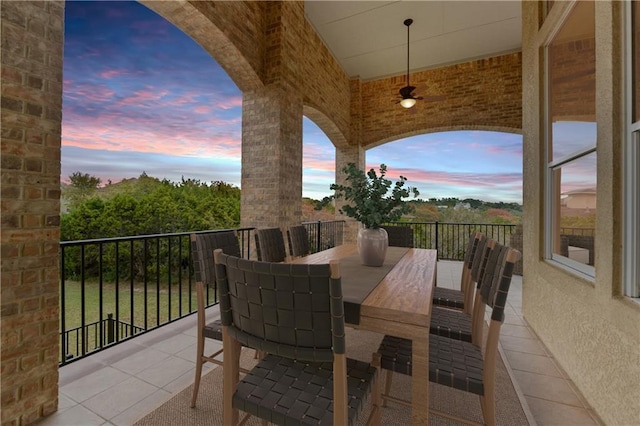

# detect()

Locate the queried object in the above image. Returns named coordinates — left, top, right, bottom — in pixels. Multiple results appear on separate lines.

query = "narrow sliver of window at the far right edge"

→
left=624, top=1, right=640, bottom=297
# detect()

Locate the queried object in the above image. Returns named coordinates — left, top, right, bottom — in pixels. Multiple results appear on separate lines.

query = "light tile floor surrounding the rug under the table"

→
left=39, top=261, right=602, bottom=426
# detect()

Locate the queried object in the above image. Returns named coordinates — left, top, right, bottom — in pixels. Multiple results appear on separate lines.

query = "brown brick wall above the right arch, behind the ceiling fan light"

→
left=362, top=53, right=522, bottom=147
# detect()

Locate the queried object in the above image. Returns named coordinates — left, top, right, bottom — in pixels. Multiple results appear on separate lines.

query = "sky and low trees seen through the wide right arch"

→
left=367, top=130, right=522, bottom=224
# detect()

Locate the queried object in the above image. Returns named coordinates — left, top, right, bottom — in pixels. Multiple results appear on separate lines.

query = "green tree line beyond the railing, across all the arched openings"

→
left=60, top=172, right=522, bottom=241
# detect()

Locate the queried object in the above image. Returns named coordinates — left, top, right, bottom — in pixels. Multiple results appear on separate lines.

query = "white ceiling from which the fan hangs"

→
left=305, top=0, right=522, bottom=80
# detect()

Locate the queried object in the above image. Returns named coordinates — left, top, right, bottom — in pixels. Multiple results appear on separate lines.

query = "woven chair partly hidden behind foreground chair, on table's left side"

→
left=190, top=231, right=245, bottom=407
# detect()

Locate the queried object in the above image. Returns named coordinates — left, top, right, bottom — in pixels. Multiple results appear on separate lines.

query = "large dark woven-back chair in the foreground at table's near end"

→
left=215, top=251, right=380, bottom=425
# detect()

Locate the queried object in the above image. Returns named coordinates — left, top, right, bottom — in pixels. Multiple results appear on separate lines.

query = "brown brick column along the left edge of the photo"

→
left=0, top=1, right=64, bottom=425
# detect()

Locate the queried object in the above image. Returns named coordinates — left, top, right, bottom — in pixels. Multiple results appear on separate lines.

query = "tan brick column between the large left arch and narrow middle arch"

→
left=241, top=2, right=304, bottom=233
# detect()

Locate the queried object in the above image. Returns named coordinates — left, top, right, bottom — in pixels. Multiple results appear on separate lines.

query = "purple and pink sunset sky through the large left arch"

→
left=61, top=2, right=242, bottom=190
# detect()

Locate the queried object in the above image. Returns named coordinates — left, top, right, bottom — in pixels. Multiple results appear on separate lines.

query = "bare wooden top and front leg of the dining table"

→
left=291, top=244, right=437, bottom=425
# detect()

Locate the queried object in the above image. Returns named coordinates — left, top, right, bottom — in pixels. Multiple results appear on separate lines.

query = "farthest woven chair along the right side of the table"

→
left=433, top=232, right=482, bottom=314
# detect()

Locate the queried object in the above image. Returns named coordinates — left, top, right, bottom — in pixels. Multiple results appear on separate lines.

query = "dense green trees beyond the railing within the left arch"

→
left=60, top=172, right=240, bottom=241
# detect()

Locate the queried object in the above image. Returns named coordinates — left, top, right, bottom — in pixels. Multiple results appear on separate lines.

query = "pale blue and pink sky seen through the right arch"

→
left=367, top=130, right=522, bottom=203
